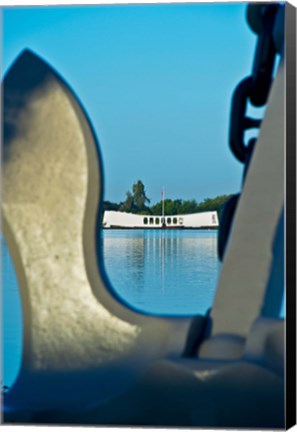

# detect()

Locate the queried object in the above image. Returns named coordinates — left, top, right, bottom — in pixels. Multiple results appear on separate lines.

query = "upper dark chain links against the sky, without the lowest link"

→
left=229, top=3, right=281, bottom=163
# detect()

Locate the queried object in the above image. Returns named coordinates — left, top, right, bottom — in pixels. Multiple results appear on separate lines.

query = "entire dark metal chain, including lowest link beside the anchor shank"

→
left=218, top=3, right=284, bottom=261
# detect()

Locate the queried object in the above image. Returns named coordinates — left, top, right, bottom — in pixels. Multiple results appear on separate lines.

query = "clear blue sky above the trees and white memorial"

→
left=3, top=3, right=255, bottom=202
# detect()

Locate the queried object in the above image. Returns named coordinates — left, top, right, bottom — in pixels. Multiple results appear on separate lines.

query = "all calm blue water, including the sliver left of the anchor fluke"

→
left=2, top=230, right=218, bottom=386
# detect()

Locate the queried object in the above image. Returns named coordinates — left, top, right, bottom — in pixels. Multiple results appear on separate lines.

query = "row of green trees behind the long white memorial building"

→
left=103, top=180, right=233, bottom=218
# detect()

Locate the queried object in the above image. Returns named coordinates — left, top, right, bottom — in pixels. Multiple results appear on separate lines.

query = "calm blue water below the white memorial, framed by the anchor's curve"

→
left=103, top=230, right=218, bottom=315
